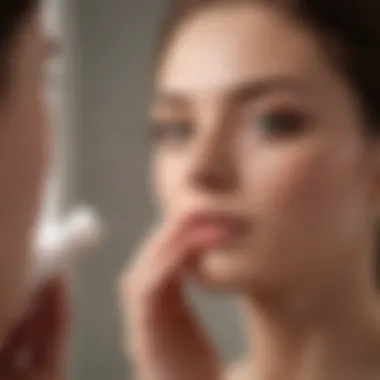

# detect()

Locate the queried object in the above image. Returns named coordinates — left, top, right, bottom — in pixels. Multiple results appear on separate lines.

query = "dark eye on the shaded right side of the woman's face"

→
left=252, top=111, right=305, bottom=136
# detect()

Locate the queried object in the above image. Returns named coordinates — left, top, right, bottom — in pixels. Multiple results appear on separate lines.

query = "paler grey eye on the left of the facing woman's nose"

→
left=153, top=122, right=193, bottom=144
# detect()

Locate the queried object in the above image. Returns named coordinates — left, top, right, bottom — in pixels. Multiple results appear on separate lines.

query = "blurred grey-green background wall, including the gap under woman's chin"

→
left=46, top=0, right=243, bottom=380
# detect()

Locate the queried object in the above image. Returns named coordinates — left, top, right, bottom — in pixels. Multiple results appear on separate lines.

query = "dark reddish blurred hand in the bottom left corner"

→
left=0, top=279, right=68, bottom=380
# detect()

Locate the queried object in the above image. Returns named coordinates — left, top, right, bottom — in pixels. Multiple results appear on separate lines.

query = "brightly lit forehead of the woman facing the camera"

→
left=157, top=5, right=332, bottom=94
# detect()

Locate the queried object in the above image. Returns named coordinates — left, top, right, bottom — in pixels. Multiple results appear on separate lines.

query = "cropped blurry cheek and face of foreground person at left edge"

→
left=0, top=11, right=48, bottom=334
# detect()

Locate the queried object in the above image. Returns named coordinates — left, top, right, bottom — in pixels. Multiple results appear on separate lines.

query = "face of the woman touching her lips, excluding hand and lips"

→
left=153, top=5, right=379, bottom=289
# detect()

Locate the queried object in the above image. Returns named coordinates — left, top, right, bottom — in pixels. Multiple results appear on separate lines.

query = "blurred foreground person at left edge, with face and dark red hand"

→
left=0, top=0, right=66, bottom=380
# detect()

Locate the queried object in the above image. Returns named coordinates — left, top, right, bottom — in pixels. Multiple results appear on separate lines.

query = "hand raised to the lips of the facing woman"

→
left=121, top=214, right=220, bottom=380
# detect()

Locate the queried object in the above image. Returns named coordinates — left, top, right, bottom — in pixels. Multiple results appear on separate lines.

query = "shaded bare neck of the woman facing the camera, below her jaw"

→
left=243, top=260, right=380, bottom=380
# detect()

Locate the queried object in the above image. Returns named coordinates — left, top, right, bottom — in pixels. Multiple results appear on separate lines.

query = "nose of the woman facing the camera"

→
left=190, top=121, right=238, bottom=193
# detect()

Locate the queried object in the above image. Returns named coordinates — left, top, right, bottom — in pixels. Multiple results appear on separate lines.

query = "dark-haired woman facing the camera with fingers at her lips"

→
left=122, top=0, right=380, bottom=380
